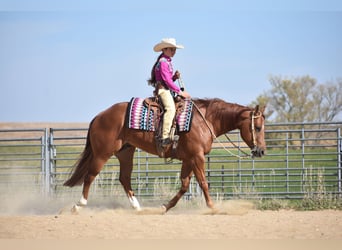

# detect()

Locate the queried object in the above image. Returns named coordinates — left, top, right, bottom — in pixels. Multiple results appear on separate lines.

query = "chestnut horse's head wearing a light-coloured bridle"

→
left=239, top=105, right=266, bottom=157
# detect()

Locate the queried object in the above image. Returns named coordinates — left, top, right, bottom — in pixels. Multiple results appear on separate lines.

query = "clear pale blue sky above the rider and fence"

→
left=0, top=0, right=342, bottom=122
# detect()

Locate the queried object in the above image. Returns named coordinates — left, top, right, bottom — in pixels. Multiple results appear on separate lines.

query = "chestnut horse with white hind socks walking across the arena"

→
left=64, top=99, right=266, bottom=212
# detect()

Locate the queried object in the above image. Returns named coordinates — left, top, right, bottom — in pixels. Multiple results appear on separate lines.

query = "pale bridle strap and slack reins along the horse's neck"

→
left=191, top=100, right=251, bottom=159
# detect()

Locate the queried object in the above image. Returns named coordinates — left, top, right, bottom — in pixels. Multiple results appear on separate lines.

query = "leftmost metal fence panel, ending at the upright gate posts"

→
left=0, top=129, right=49, bottom=196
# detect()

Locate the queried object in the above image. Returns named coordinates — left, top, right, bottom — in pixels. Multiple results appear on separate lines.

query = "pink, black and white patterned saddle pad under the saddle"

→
left=126, top=97, right=193, bottom=132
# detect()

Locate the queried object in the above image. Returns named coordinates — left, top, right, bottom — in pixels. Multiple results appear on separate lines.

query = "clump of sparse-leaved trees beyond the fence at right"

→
left=253, top=76, right=342, bottom=122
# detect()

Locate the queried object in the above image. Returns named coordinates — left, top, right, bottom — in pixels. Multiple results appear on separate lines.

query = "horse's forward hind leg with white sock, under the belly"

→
left=116, top=144, right=141, bottom=211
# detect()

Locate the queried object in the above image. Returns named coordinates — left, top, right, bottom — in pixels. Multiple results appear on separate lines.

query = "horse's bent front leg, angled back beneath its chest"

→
left=163, top=161, right=192, bottom=212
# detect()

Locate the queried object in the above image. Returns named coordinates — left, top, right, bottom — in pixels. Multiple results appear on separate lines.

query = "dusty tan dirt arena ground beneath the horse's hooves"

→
left=0, top=197, right=342, bottom=239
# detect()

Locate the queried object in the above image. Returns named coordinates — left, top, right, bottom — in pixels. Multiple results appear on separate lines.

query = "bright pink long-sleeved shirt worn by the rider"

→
left=154, top=55, right=180, bottom=94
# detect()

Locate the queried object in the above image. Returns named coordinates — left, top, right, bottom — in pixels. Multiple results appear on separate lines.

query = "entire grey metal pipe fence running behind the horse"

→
left=0, top=122, right=342, bottom=199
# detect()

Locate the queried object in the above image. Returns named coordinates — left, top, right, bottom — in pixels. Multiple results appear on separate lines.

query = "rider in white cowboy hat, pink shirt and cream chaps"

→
left=148, top=38, right=190, bottom=147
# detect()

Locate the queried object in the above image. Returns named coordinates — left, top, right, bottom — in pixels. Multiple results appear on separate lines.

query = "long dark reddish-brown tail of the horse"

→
left=63, top=117, right=96, bottom=187
